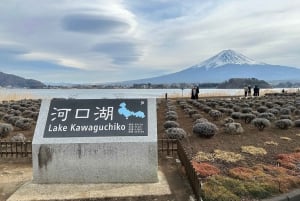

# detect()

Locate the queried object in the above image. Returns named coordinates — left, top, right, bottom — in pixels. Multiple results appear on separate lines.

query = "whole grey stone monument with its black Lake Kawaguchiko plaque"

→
left=32, top=99, right=158, bottom=183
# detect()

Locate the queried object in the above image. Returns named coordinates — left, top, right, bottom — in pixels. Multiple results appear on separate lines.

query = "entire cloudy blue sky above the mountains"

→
left=0, top=0, right=300, bottom=83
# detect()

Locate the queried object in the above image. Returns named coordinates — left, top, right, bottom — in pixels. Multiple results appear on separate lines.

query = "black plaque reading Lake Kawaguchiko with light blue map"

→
left=44, top=99, right=148, bottom=138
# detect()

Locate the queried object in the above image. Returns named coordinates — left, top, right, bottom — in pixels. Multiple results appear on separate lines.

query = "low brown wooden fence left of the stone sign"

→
left=0, top=140, right=32, bottom=158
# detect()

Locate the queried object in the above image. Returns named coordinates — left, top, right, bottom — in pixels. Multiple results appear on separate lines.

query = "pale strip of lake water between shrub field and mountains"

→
left=0, top=88, right=296, bottom=100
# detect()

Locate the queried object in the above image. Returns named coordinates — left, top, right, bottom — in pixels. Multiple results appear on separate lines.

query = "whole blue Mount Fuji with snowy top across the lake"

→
left=123, top=50, right=300, bottom=84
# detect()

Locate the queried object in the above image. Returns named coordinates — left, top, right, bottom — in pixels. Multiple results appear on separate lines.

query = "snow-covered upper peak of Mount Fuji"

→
left=194, top=50, right=265, bottom=69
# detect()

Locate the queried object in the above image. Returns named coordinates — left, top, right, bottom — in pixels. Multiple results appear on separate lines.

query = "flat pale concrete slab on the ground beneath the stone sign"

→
left=7, top=170, right=172, bottom=201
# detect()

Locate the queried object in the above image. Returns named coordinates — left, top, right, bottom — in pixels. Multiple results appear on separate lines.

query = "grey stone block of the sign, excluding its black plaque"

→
left=32, top=99, right=158, bottom=184
